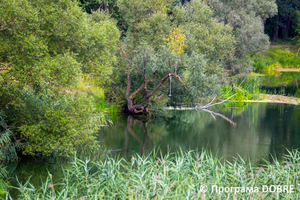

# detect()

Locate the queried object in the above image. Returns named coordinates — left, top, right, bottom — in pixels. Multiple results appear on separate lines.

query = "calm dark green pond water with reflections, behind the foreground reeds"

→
left=103, top=103, right=300, bottom=164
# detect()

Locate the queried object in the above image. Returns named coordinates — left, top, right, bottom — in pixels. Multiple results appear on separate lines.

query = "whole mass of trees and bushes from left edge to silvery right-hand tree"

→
left=0, top=0, right=294, bottom=156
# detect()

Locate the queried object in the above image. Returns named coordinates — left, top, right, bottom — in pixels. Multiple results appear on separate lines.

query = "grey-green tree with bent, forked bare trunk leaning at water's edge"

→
left=110, top=0, right=234, bottom=113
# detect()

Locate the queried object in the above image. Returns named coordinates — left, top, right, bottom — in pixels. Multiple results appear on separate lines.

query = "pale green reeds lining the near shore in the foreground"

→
left=4, top=151, right=300, bottom=199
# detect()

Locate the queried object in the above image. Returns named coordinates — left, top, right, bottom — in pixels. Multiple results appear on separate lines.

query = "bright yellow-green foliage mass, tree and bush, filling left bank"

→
left=0, top=0, right=119, bottom=158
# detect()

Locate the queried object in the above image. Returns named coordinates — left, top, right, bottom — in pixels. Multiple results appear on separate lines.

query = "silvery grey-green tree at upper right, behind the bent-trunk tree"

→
left=204, top=0, right=277, bottom=73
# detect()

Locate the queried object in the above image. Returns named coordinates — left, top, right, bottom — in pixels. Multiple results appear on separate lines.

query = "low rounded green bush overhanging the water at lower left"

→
left=3, top=89, right=106, bottom=156
